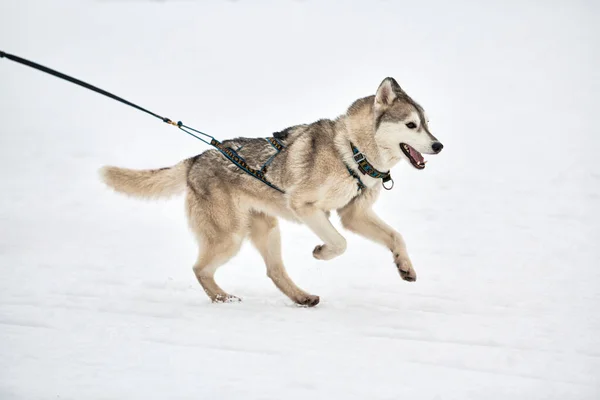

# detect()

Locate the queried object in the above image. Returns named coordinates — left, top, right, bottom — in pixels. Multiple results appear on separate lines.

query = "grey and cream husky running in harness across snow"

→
left=101, top=78, right=443, bottom=307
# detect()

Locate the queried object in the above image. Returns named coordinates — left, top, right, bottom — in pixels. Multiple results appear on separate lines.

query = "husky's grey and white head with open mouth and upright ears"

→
left=374, top=78, right=444, bottom=169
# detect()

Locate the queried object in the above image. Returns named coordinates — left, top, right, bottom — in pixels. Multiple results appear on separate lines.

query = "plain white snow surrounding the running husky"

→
left=0, top=0, right=600, bottom=400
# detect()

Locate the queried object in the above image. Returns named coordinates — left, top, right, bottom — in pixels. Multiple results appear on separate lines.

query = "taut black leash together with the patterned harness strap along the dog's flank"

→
left=0, top=50, right=285, bottom=193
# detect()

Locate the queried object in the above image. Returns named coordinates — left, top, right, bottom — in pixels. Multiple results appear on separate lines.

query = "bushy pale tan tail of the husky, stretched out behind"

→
left=100, top=159, right=190, bottom=198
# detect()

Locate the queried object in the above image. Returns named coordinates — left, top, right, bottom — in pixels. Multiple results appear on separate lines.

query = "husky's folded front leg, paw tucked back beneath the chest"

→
left=292, top=203, right=346, bottom=260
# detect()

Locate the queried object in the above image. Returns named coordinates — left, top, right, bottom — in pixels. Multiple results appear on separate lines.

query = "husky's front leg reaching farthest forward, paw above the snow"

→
left=338, top=203, right=417, bottom=282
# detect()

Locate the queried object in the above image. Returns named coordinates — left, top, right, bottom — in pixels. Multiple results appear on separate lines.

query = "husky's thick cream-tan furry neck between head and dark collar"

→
left=335, top=96, right=400, bottom=176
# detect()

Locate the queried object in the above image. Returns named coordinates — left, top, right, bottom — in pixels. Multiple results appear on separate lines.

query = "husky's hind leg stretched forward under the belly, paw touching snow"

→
left=250, top=213, right=319, bottom=307
